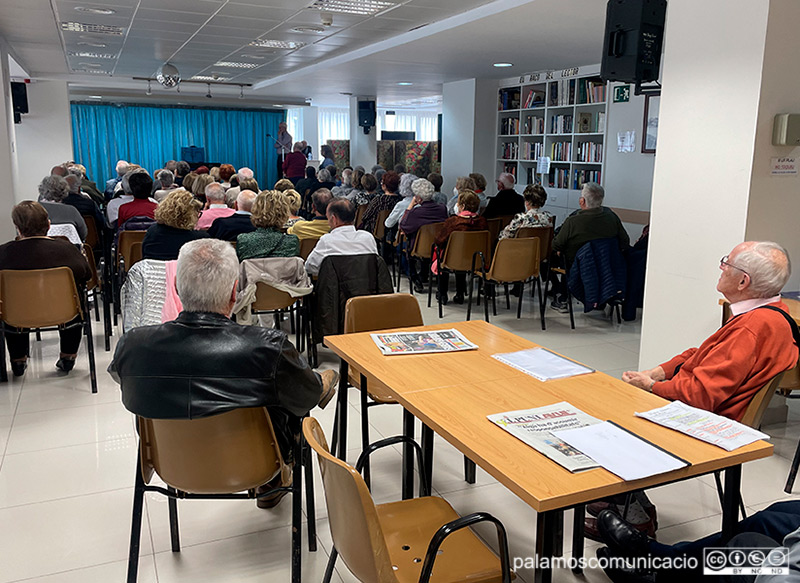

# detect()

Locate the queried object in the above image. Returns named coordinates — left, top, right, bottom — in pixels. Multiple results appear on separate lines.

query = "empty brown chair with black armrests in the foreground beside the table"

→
left=303, top=418, right=513, bottom=583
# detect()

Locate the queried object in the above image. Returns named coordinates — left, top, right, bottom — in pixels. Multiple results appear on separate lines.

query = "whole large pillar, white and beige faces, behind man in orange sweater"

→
left=639, top=0, right=800, bottom=368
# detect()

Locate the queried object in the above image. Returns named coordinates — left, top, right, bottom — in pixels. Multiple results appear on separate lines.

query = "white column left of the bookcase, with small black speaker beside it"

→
left=442, top=79, right=498, bottom=193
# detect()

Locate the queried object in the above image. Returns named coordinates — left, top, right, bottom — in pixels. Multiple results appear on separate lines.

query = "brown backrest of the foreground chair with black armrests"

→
left=303, top=417, right=397, bottom=583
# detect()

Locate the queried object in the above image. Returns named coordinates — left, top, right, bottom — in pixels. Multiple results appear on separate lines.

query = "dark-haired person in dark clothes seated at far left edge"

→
left=0, top=200, right=92, bottom=376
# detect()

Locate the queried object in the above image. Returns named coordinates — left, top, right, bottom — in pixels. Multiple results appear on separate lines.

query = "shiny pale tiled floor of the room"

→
left=0, top=288, right=800, bottom=583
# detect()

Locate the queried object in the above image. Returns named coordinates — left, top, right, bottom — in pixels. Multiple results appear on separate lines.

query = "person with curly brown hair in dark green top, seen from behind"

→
left=236, top=190, right=300, bottom=261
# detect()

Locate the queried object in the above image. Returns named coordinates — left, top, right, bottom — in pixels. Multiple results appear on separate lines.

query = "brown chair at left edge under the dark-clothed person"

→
left=0, top=267, right=97, bottom=393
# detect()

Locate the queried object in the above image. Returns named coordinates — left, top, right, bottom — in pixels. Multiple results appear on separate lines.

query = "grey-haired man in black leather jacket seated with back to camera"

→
left=108, top=237, right=338, bottom=507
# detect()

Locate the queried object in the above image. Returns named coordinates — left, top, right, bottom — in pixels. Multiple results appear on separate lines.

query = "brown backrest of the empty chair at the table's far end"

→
left=344, top=294, right=424, bottom=334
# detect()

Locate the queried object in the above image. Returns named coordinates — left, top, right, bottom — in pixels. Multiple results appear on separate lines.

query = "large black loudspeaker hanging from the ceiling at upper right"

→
left=600, top=0, right=667, bottom=83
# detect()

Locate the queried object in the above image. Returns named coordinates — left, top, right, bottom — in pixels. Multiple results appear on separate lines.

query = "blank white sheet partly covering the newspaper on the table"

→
left=553, top=421, right=689, bottom=481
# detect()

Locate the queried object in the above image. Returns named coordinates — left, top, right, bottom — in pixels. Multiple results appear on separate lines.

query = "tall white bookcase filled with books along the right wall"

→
left=496, top=65, right=608, bottom=224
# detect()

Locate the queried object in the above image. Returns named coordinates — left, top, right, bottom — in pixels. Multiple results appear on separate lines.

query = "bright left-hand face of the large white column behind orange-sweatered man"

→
left=639, top=0, right=768, bottom=368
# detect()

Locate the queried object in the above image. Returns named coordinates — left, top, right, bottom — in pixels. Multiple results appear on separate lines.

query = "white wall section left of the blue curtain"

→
left=14, top=81, right=72, bottom=201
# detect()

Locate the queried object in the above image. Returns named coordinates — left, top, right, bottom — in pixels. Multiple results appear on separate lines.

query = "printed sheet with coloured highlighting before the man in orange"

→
left=636, top=401, right=769, bottom=451
